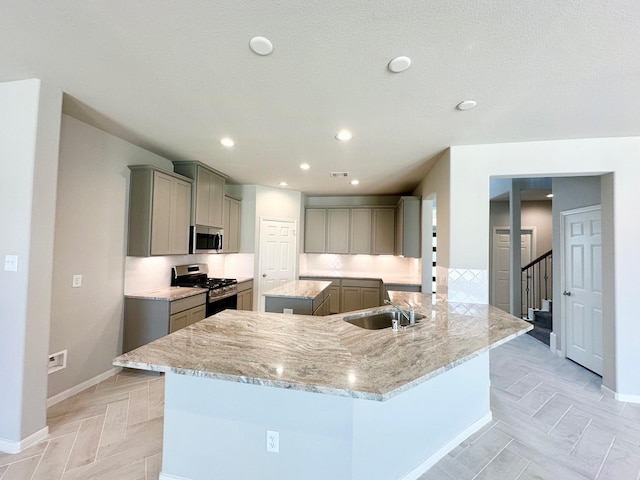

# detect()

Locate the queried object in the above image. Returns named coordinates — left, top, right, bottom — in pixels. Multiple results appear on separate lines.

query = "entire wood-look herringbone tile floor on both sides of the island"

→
left=0, top=335, right=640, bottom=480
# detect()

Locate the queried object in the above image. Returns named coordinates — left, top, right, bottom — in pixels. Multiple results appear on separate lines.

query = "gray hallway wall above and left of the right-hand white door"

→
left=552, top=176, right=613, bottom=348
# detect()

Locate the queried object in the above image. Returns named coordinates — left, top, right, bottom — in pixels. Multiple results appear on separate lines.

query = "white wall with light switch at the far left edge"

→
left=0, top=79, right=62, bottom=450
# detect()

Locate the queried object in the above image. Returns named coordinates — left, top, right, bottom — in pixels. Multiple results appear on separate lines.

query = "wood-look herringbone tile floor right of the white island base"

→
left=420, top=335, right=640, bottom=480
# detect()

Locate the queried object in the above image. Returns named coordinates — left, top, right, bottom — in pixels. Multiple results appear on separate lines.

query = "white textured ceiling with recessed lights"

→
left=0, top=0, right=640, bottom=195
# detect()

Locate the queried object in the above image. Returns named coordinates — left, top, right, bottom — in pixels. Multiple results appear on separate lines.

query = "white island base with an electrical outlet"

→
left=160, top=351, right=491, bottom=480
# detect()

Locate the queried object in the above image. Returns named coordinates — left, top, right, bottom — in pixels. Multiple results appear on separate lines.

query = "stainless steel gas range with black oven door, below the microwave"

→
left=171, top=263, right=238, bottom=317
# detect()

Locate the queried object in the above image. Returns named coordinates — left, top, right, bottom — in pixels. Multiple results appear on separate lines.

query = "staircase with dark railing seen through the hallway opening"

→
left=521, top=250, right=553, bottom=345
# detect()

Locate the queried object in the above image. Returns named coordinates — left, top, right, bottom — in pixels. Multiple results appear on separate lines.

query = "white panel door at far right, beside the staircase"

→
left=562, top=206, right=602, bottom=375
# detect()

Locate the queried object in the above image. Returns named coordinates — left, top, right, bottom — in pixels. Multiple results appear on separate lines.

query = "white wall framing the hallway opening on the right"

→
left=442, top=137, right=640, bottom=401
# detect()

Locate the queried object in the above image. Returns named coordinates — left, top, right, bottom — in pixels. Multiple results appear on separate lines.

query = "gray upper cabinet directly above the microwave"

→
left=173, top=161, right=225, bottom=228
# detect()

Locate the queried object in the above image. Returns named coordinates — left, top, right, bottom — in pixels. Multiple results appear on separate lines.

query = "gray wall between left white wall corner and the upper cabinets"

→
left=49, top=115, right=173, bottom=396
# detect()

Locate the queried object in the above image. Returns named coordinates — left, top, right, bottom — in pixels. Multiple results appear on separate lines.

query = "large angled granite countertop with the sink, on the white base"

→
left=113, top=293, right=532, bottom=401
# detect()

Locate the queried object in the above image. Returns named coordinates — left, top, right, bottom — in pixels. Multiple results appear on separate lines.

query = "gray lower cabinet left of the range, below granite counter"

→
left=123, top=293, right=207, bottom=352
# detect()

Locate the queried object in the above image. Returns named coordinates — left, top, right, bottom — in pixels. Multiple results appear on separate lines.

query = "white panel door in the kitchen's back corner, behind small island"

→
left=258, top=219, right=297, bottom=311
